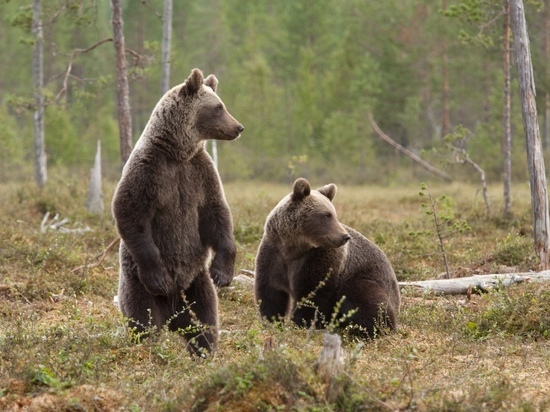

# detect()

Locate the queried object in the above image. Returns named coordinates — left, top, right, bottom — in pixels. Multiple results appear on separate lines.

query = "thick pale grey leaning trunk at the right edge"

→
left=510, top=0, right=550, bottom=270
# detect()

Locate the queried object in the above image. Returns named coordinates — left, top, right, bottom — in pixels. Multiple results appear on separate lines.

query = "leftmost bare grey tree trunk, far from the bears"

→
left=32, top=0, right=48, bottom=189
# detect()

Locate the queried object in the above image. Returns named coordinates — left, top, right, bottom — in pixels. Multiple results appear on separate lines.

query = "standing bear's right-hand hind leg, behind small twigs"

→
left=169, top=272, right=218, bottom=356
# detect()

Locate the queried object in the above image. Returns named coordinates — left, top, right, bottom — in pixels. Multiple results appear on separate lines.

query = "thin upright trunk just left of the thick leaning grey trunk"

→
left=502, top=0, right=512, bottom=216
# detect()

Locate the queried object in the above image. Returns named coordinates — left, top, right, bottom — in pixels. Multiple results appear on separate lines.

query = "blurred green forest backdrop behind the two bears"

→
left=0, top=0, right=550, bottom=185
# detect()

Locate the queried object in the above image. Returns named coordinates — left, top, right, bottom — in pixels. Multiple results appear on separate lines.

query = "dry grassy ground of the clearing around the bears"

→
left=0, top=172, right=550, bottom=411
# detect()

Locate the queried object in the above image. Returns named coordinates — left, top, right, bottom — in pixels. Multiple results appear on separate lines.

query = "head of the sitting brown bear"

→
left=266, top=178, right=351, bottom=251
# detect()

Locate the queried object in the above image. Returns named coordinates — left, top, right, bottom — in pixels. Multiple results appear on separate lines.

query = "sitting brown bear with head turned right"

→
left=255, top=178, right=401, bottom=337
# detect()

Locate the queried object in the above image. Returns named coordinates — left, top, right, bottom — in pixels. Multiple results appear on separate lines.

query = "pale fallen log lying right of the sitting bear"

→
left=398, top=270, right=550, bottom=295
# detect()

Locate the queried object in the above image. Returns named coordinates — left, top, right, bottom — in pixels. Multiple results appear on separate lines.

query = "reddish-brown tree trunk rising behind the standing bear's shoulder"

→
left=111, top=0, right=133, bottom=166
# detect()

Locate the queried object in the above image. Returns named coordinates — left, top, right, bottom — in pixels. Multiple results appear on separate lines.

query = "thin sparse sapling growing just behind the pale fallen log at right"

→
left=416, top=183, right=472, bottom=278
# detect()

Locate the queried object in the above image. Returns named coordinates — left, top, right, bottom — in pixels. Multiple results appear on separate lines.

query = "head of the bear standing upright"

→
left=178, top=69, right=244, bottom=140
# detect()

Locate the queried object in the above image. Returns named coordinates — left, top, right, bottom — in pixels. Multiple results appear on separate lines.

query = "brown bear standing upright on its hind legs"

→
left=112, top=69, right=244, bottom=353
